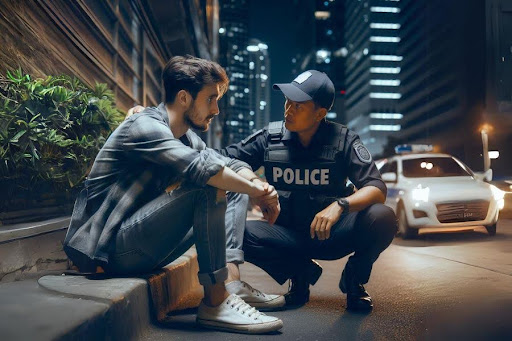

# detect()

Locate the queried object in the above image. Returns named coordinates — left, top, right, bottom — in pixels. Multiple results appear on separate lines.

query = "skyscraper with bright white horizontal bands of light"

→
left=344, top=0, right=403, bottom=154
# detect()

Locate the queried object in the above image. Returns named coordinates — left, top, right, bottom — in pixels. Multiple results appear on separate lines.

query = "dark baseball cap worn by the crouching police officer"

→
left=273, top=70, right=334, bottom=110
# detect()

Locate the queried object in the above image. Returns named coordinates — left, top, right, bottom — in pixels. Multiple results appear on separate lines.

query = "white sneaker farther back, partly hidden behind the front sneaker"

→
left=226, top=281, right=286, bottom=311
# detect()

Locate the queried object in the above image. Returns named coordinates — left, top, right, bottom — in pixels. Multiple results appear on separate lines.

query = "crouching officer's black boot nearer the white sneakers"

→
left=284, top=260, right=322, bottom=306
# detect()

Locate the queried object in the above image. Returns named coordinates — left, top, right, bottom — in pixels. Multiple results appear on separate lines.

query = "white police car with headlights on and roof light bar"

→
left=377, top=145, right=504, bottom=239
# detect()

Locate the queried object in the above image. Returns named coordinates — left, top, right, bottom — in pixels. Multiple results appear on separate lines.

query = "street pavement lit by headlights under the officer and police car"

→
left=142, top=219, right=512, bottom=340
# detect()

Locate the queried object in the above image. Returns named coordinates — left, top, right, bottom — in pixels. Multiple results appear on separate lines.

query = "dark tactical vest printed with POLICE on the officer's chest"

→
left=264, top=121, right=347, bottom=196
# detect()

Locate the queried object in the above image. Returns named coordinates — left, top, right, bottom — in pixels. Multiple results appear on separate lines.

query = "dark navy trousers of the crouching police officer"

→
left=243, top=204, right=397, bottom=284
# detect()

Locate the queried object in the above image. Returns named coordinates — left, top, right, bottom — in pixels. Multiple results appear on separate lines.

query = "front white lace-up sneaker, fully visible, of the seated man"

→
left=196, top=294, right=283, bottom=334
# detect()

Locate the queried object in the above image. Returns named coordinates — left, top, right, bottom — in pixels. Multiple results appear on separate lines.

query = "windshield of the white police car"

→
left=402, top=157, right=471, bottom=178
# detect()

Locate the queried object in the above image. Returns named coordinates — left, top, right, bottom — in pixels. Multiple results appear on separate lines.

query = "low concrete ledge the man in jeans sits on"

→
left=0, top=248, right=202, bottom=341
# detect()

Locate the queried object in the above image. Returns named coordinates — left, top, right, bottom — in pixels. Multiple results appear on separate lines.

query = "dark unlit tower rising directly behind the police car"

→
left=397, top=0, right=486, bottom=169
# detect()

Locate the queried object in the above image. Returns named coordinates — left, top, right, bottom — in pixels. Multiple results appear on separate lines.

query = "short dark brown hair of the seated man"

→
left=162, top=55, right=229, bottom=103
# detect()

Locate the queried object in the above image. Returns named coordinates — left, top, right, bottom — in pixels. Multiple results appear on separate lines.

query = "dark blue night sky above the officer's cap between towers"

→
left=249, top=0, right=314, bottom=121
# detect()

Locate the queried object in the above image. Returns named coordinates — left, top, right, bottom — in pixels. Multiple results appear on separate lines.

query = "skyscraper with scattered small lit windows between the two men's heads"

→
left=219, top=0, right=270, bottom=145
